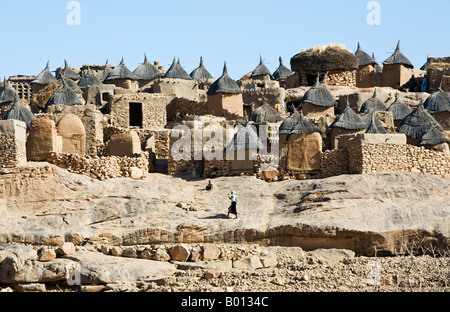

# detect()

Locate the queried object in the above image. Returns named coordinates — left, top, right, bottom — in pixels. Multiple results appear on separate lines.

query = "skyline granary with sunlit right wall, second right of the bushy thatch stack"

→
left=381, top=40, right=414, bottom=89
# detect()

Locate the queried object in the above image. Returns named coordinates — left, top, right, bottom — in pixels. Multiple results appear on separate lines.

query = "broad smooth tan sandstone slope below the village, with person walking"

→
left=0, top=163, right=450, bottom=261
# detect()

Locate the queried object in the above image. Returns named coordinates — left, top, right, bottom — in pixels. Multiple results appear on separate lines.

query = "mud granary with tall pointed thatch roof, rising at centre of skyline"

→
left=206, top=63, right=244, bottom=116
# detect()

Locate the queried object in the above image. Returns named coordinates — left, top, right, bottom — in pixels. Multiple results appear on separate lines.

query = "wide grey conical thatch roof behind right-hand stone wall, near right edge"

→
left=397, top=103, right=444, bottom=138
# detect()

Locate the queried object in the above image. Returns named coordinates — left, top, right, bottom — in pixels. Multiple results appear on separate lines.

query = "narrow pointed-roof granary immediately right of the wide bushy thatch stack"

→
left=355, top=42, right=381, bottom=88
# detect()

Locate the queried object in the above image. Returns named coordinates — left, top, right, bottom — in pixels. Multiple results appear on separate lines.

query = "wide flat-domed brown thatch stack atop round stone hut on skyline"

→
left=291, top=46, right=359, bottom=73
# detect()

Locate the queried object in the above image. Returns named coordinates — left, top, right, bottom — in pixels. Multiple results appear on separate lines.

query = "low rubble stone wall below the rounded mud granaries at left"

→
left=47, top=152, right=153, bottom=181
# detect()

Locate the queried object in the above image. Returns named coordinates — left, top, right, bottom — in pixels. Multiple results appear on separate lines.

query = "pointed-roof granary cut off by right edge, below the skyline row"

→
left=423, top=87, right=450, bottom=131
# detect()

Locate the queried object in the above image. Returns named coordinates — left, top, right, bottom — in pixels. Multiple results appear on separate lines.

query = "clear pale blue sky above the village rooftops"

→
left=0, top=0, right=450, bottom=79
